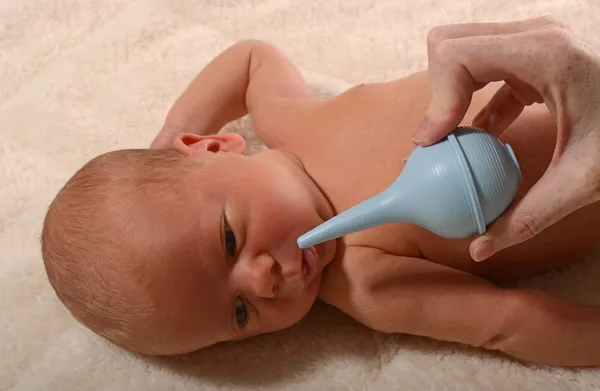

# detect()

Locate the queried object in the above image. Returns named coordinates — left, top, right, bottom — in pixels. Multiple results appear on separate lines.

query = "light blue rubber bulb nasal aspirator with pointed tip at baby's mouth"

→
left=298, top=126, right=522, bottom=248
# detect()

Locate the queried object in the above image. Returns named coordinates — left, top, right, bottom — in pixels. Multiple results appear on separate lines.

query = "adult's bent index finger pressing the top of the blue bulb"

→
left=414, top=31, right=552, bottom=146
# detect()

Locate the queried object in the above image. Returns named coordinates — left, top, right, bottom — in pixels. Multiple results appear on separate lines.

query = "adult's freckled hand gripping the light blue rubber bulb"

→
left=414, top=17, right=600, bottom=261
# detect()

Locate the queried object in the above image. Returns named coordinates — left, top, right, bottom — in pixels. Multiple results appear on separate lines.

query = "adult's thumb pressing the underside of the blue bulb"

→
left=470, top=156, right=594, bottom=262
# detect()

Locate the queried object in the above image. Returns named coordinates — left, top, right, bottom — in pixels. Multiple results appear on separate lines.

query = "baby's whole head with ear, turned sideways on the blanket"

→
left=42, top=134, right=335, bottom=355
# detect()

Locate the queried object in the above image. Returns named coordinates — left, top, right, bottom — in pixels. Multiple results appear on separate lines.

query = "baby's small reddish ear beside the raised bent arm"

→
left=175, top=133, right=246, bottom=156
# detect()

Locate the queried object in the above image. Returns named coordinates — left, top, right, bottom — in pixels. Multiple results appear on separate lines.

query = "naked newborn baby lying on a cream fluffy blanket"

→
left=42, top=41, right=600, bottom=366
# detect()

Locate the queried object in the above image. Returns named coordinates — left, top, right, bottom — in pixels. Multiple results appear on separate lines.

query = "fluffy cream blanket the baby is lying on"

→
left=0, top=0, right=600, bottom=391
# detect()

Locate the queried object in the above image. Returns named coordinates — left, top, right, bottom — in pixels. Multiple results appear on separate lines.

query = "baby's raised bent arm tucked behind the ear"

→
left=151, top=40, right=311, bottom=148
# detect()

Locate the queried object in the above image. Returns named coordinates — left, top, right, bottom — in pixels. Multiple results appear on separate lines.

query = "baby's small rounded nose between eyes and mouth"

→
left=244, top=255, right=281, bottom=298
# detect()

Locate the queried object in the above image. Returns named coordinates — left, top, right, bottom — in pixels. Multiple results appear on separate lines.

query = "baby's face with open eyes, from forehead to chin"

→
left=144, top=142, right=335, bottom=353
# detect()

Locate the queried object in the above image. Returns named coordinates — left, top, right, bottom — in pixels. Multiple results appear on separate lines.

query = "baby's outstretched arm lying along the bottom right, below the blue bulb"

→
left=322, top=248, right=600, bottom=366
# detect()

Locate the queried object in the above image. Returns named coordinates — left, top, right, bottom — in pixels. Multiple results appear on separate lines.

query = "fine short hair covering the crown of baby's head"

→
left=41, top=149, right=197, bottom=354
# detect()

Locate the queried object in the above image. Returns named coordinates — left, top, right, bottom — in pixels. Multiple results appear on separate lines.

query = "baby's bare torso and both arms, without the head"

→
left=152, top=41, right=600, bottom=366
